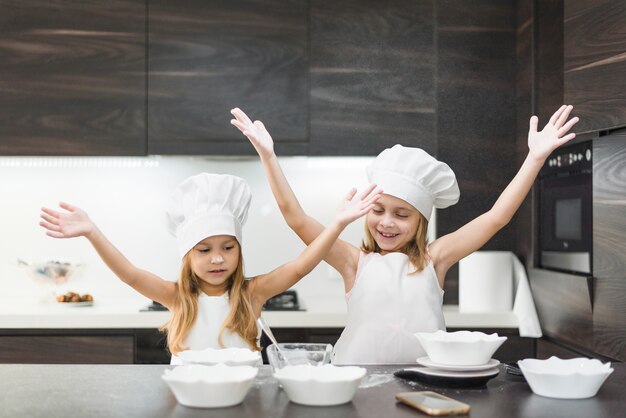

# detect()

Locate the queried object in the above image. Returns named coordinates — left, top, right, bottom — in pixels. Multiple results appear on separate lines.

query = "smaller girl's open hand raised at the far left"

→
left=39, top=202, right=95, bottom=238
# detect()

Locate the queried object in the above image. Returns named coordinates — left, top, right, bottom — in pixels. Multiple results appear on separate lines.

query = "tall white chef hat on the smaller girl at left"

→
left=166, top=173, right=252, bottom=257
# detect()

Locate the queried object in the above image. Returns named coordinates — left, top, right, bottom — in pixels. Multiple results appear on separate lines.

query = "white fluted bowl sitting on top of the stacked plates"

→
left=415, top=330, right=506, bottom=366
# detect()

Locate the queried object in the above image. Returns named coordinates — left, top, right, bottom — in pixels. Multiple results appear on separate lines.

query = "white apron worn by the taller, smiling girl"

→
left=333, top=252, right=446, bottom=364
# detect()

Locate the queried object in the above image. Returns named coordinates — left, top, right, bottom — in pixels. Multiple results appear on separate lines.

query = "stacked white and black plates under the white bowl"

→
left=395, top=357, right=500, bottom=388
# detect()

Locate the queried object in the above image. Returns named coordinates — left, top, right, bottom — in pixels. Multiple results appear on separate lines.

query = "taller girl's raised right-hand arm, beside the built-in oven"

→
left=429, top=105, right=578, bottom=285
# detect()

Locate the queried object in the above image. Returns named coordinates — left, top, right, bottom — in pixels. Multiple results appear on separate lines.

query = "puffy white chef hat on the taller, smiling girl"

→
left=366, top=145, right=460, bottom=220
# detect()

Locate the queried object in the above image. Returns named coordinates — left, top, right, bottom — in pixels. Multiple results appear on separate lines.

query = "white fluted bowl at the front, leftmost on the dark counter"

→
left=161, top=364, right=259, bottom=408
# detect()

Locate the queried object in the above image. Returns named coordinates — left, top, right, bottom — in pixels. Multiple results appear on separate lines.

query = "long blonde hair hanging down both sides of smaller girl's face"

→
left=160, top=246, right=259, bottom=354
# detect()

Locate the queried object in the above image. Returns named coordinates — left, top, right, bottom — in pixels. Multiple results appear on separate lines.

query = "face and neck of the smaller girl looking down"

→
left=189, top=235, right=239, bottom=296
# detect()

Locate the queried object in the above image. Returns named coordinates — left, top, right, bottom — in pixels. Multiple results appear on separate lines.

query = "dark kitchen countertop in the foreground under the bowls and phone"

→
left=0, top=363, right=626, bottom=418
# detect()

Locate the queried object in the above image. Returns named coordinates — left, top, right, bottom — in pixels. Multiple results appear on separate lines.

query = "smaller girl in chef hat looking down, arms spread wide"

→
left=40, top=173, right=380, bottom=363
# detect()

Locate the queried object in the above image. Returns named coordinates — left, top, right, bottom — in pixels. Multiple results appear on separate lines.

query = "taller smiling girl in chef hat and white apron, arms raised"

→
left=231, top=106, right=578, bottom=364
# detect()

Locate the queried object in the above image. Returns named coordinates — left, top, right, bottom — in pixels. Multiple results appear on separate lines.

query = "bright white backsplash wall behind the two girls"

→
left=0, top=156, right=371, bottom=309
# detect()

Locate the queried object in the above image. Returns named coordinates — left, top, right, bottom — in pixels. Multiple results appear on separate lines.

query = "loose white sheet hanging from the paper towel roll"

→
left=511, top=253, right=542, bottom=338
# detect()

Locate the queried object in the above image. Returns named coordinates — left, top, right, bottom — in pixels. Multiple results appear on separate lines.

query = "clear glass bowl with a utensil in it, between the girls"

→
left=267, top=343, right=333, bottom=372
